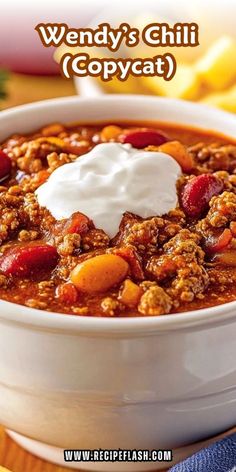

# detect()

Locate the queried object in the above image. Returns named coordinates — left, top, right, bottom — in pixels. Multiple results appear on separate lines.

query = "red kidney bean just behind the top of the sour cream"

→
left=120, top=128, right=168, bottom=149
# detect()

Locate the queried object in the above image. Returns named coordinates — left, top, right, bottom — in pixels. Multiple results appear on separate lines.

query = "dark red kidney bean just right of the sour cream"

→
left=181, top=174, right=223, bottom=218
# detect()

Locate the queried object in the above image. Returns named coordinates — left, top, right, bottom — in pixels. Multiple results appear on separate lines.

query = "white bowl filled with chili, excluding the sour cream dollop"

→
left=0, top=96, right=236, bottom=470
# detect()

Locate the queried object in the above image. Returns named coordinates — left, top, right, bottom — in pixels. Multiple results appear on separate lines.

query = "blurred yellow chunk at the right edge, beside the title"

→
left=195, top=36, right=236, bottom=90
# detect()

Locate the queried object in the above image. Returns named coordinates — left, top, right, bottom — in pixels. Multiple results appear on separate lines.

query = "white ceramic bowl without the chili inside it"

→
left=0, top=95, right=236, bottom=471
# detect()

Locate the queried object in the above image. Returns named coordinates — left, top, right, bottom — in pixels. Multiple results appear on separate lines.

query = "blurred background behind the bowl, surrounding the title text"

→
left=0, top=0, right=236, bottom=112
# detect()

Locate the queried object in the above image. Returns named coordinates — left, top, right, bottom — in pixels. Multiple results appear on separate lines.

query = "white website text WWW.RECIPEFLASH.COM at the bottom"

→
left=64, top=449, right=173, bottom=462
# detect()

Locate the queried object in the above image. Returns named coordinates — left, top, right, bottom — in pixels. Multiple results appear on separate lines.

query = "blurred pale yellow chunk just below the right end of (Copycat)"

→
left=143, top=64, right=203, bottom=100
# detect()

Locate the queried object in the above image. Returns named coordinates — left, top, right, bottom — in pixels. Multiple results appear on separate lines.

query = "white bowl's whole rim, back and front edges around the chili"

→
left=0, top=94, right=236, bottom=337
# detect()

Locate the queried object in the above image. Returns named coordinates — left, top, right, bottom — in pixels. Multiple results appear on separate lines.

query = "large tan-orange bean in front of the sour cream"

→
left=70, top=254, right=129, bottom=293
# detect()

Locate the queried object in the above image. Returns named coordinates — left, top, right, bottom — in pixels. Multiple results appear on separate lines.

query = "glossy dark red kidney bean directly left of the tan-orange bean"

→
left=0, top=244, right=58, bottom=277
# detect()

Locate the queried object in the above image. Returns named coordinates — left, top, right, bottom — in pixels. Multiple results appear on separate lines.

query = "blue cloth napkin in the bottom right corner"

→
left=169, top=433, right=236, bottom=472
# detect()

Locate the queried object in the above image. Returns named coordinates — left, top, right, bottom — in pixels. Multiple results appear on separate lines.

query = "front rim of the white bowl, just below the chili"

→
left=0, top=300, right=236, bottom=338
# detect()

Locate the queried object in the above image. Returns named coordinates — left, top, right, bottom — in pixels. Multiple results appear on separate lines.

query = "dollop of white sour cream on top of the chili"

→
left=36, top=143, right=181, bottom=237
